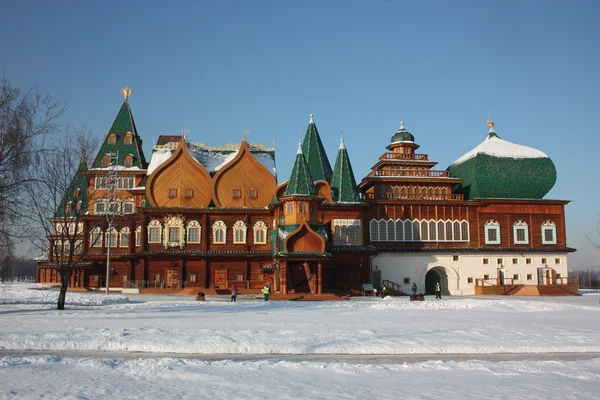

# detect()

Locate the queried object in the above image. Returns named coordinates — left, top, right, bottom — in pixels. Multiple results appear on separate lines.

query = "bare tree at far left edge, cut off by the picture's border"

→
left=0, top=77, right=65, bottom=253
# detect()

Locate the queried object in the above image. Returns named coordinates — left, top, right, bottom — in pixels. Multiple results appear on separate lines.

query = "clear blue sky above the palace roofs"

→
left=0, top=0, right=600, bottom=268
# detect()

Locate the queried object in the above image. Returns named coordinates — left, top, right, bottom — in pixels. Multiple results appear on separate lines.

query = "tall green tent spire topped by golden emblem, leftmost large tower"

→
left=92, top=88, right=148, bottom=169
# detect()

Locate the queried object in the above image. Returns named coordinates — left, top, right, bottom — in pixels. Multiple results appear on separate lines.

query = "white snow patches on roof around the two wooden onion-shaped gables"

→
left=147, top=142, right=277, bottom=177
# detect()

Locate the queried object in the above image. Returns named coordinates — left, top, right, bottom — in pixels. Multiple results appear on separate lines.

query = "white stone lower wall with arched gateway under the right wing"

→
left=371, top=253, right=568, bottom=296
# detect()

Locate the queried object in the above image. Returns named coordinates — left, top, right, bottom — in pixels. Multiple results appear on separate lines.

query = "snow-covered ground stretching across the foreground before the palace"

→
left=0, top=284, right=600, bottom=400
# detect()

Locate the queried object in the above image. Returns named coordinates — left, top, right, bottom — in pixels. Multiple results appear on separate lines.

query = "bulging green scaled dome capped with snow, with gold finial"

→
left=448, top=121, right=556, bottom=200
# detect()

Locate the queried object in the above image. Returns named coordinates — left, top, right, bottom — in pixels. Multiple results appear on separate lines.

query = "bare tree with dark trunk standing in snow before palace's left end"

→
left=26, top=130, right=101, bottom=310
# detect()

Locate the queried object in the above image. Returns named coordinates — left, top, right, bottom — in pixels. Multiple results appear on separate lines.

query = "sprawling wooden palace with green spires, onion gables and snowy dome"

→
left=36, top=92, right=575, bottom=295
